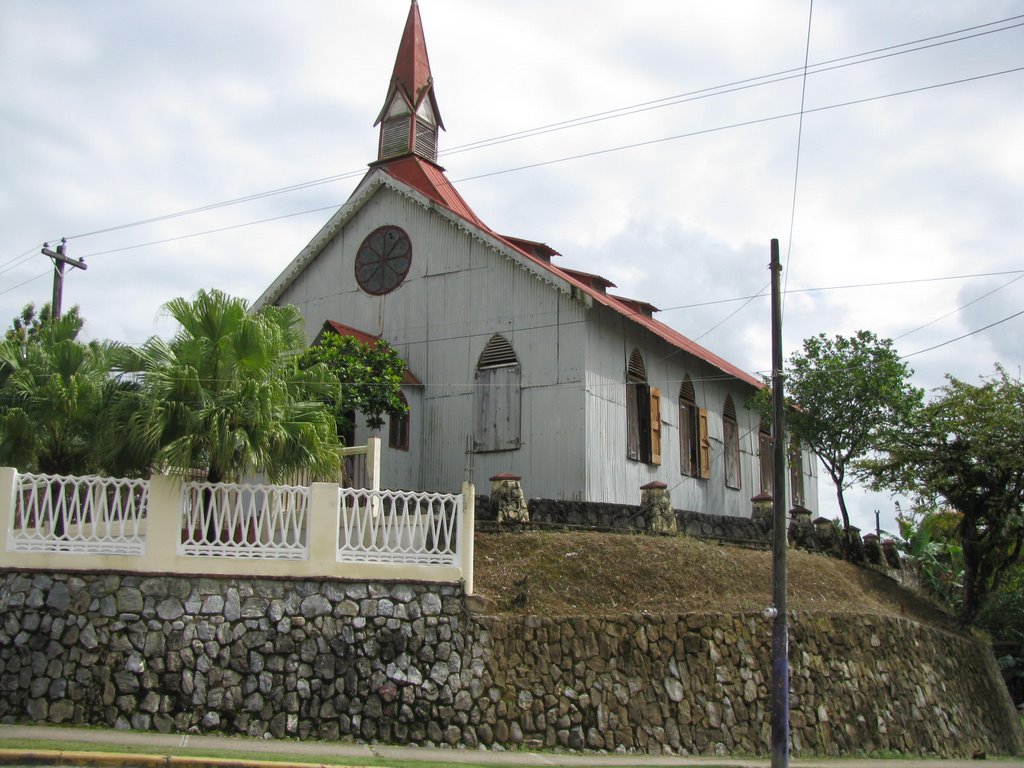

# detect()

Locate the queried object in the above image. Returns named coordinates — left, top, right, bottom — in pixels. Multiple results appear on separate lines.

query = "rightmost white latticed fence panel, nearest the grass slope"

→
left=338, top=488, right=462, bottom=565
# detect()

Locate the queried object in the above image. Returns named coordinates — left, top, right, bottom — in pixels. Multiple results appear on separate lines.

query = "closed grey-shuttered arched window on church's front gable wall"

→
left=473, top=334, right=522, bottom=453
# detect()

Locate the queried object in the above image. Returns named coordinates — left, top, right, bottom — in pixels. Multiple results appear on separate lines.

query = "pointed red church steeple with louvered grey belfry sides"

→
left=374, top=0, right=444, bottom=163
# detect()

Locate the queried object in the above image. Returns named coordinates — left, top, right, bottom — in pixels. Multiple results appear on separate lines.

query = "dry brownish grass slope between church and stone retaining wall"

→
left=474, top=531, right=954, bottom=628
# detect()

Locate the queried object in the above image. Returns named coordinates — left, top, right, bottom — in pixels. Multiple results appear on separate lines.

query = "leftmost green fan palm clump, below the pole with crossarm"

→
left=0, top=304, right=123, bottom=474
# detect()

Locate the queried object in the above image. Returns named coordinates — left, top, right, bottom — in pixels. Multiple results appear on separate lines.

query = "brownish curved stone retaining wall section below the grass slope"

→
left=482, top=613, right=1024, bottom=756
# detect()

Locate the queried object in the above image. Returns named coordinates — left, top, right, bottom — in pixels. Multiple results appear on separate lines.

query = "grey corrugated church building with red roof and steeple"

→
left=256, top=0, right=817, bottom=517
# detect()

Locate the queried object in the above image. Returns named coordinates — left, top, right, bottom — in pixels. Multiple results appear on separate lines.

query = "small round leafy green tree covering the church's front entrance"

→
left=299, top=333, right=408, bottom=433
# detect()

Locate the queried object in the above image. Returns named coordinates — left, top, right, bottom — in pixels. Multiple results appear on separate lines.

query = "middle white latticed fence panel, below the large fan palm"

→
left=178, top=482, right=309, bottom=560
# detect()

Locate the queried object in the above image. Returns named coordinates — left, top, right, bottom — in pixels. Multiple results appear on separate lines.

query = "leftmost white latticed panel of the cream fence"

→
left=8, top=474, right=150, bottom=555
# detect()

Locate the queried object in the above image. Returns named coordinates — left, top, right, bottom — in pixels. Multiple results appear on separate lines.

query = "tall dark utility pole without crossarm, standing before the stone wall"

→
left=769, top=238, right=790, bottom=768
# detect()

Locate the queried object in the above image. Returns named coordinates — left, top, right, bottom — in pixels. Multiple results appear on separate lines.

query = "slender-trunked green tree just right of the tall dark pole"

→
left=754, top=331, right=924, bottom=530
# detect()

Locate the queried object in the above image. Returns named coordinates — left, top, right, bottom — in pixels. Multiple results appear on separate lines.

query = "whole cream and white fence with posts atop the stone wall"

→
left=0, top=467, right=474, bottom=594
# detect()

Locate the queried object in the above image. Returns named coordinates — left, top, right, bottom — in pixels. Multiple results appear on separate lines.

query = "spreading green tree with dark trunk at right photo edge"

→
left=864, top=366, right=1024, bottom=624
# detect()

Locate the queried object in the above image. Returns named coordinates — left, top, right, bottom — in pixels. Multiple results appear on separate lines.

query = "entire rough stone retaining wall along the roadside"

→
left=0, top=571, right=1024, bottom=755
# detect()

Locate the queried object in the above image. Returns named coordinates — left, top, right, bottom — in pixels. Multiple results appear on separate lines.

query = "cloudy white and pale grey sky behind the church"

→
left=0, top=0, right=1024, bottom=527
